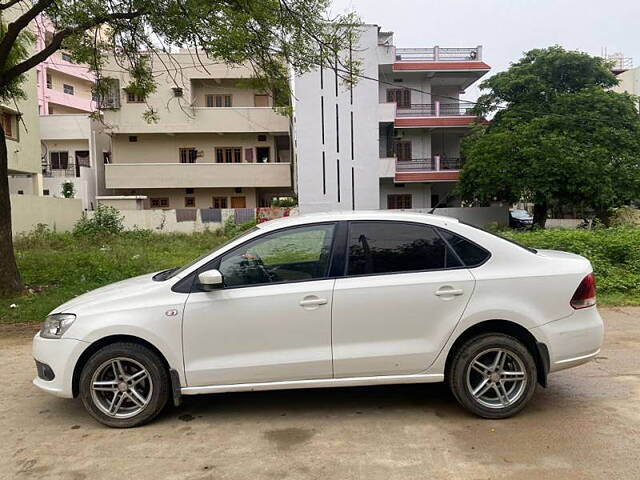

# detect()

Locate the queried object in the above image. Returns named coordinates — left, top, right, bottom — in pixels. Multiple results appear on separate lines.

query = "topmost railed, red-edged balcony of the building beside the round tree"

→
left=393, top=45, right=490, bottom=74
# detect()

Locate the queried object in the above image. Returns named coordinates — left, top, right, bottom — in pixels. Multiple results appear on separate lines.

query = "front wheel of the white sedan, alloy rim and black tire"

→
left=79, top=342, right=171, bottom=428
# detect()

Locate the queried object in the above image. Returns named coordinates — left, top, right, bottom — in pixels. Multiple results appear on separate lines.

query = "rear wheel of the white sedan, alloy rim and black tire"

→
left=447, top=333, right=538, bottom=419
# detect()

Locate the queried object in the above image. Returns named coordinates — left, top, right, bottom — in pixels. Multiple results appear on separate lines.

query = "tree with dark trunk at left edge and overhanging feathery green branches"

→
left=0, top=0, right=359, bottom=294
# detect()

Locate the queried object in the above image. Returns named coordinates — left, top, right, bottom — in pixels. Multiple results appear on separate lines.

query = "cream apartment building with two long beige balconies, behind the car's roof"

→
left=102, top=52, right=292, bottom=209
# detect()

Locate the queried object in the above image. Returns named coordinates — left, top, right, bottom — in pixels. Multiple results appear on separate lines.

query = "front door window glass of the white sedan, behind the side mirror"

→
left=219, top=225, right=334, bottom=287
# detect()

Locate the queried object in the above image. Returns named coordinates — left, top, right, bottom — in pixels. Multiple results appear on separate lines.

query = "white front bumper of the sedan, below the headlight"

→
left=33, top=333, right=89, bottom=398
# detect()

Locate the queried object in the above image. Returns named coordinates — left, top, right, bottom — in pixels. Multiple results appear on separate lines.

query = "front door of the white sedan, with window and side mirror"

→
left=183, top=223, right=335, bottom=386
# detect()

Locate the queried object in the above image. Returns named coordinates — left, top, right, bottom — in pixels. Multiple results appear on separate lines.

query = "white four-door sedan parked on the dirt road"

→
left=33, top=212, right=603, bottom=427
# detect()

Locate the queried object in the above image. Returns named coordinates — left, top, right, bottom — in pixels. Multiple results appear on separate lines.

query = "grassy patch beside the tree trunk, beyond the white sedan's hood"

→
left=0, top=231, right=227, bottom=323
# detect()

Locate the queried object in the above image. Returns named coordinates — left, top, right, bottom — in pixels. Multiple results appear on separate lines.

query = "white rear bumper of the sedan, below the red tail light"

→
left=531, top=307, right=604, bottom=373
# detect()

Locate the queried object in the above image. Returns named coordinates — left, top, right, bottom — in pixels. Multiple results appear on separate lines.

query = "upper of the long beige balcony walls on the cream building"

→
left=105, top=103, right=289, bottom=134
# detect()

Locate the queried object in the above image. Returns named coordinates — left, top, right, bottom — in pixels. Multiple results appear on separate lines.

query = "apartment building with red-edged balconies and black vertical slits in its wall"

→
left=294, top=25, right=490, bottom=211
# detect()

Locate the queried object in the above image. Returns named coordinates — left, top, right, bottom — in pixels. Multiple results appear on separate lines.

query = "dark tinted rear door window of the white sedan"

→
left=348, top=222, right=460, bottom=275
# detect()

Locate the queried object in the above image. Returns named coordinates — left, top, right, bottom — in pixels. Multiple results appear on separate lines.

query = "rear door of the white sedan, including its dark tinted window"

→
left=332, top=221, right=475, bottom=377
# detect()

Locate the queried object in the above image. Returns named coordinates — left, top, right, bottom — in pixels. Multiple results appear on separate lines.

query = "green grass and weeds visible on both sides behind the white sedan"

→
left=0, top=225, right=640, bottom=323
